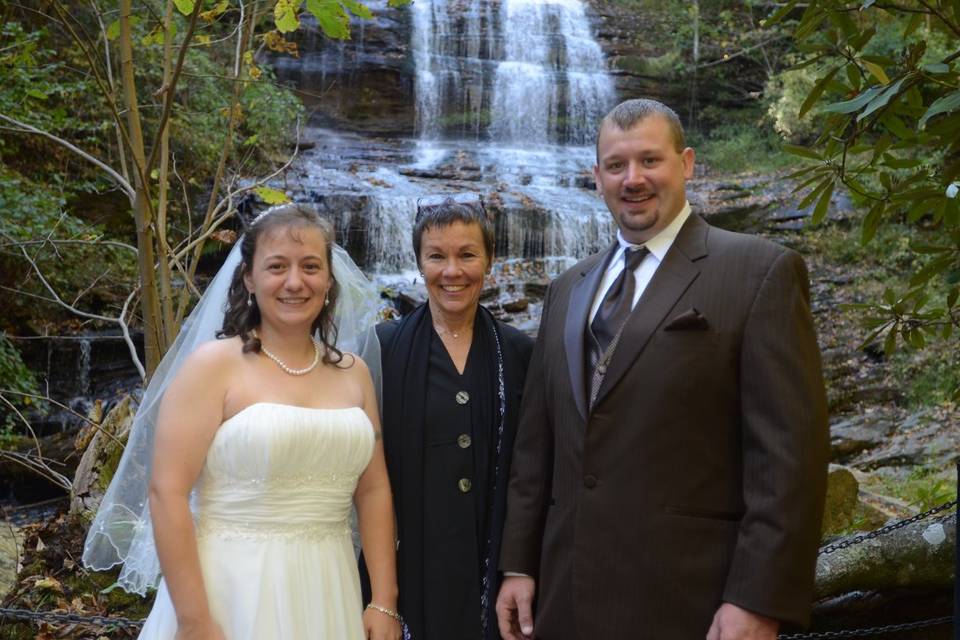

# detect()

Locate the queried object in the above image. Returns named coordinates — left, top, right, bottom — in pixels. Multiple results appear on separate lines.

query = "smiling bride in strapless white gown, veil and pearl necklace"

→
left=84, top=205, right=401, bottom=640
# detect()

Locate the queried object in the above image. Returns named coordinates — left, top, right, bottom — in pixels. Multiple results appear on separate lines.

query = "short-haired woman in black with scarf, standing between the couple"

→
left=364, top=195, right=533, bottom=640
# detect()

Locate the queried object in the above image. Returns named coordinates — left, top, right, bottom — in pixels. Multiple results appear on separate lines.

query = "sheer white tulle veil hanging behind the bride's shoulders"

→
left=83, top=210, right=381, bottom=595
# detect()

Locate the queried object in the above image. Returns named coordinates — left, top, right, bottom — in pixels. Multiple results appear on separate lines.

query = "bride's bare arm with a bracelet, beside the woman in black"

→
left=352, top=358, right=400, bottom=638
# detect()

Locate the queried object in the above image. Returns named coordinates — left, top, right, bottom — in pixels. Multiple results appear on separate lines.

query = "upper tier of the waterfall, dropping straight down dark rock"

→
left=411, top=0, right=615, bottom=144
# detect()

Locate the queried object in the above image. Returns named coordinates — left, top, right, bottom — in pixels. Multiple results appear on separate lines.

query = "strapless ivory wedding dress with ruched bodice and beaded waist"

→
left=140, top=402, right=374, bottom=640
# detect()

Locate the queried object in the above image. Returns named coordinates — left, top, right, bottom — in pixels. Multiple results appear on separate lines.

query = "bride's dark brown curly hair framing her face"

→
left=217, top=204, right=343, bottom=364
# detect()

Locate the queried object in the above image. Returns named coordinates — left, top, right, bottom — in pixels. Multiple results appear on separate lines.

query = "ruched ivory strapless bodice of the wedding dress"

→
left=195, top=402, right=374, bottom=538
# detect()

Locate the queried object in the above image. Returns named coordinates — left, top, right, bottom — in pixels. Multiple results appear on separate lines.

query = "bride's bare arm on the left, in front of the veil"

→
left=150, top=343, right=226, bottom=638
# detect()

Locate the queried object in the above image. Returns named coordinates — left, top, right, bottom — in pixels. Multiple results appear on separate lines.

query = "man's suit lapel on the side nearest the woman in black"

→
left=563, top=244, right=617, bottom=421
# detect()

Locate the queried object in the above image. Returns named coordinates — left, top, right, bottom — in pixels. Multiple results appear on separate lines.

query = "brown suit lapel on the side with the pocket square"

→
left=594, top=214, right=710, bottom=406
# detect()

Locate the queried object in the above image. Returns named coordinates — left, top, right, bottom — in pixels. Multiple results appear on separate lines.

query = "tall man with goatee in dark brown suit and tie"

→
left=497, top=100, right=828, bottom=640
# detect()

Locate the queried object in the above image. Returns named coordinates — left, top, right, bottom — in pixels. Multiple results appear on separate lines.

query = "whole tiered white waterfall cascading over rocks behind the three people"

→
left=266, top=0, right=616, bottom=279
